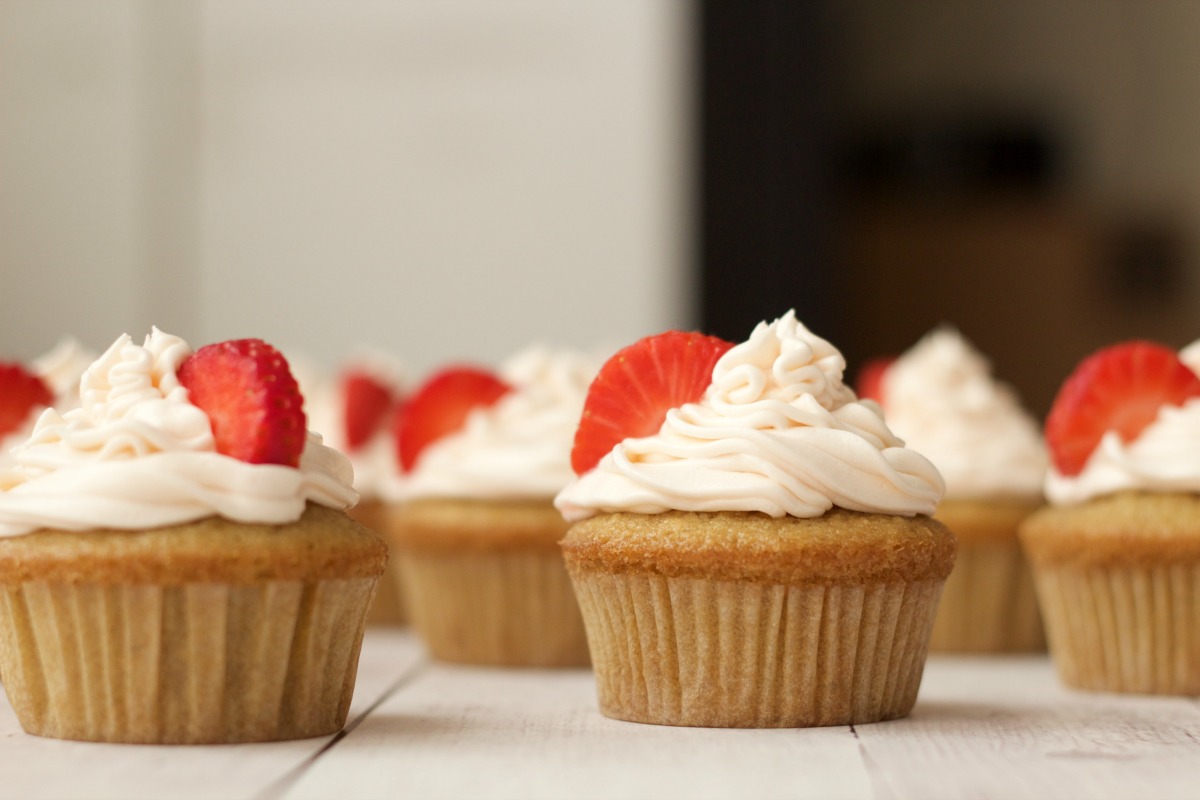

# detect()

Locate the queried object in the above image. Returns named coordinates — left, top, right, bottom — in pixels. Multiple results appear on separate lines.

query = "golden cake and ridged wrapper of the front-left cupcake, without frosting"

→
left=0, top=505, right=386, bottom=744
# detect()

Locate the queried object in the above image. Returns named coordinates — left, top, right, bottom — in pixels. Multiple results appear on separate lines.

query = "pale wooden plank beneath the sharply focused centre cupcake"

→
left=284, top=664, right=871, bottom=800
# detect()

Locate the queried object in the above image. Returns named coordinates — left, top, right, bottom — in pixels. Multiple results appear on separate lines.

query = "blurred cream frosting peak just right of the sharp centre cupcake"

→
left=882, top=326, right=1048, bottom=499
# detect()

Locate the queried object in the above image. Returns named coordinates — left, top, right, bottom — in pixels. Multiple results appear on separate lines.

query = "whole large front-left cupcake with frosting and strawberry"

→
left=0, top=329, right=386, bottom=744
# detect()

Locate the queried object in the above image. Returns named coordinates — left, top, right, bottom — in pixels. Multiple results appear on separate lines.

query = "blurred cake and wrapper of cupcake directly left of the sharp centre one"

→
left=390, top=499, right=589, bottom=667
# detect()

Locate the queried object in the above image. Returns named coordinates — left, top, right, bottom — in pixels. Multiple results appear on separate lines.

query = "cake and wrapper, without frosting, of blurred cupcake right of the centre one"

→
left=929, top=500, right=1046, bottom=654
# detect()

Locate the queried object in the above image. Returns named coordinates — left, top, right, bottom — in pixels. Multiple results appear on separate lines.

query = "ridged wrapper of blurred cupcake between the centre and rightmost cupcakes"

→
left=929, top=540, right=1046, bottom=652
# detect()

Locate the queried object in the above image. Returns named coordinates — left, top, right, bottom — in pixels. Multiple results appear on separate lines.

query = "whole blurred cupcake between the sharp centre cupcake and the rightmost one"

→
left=859, top=326, right=1046, bottom=652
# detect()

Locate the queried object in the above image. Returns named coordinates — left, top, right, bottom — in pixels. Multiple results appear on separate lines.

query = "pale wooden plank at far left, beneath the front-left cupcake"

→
left=0, top=628, right=424, bottom=800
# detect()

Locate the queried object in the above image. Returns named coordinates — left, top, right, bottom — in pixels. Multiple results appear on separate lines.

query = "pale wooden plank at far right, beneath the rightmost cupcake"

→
left=856, top=656, right=1200, bottom=800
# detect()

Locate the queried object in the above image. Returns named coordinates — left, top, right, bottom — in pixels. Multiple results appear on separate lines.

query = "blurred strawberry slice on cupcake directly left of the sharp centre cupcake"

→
left=395, top=366, right=510, bottom=471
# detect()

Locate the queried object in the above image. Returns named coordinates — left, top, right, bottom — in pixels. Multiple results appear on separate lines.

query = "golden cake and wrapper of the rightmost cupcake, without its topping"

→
left=1021, top=492, right=1200, bottom=697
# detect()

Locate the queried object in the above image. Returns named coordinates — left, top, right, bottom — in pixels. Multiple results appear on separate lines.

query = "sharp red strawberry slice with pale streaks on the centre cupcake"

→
left=571, top=331, right=733, bottom=475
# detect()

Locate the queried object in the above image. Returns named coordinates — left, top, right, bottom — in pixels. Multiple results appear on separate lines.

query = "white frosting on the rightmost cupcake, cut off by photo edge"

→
left=1045, top=342, right=1200, bottom=505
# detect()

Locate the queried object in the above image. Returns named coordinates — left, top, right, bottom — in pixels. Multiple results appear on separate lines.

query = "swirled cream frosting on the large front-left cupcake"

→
left=0, top=329, right=358, bottom=536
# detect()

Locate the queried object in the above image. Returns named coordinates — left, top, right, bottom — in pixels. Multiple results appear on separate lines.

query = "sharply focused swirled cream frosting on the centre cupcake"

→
left=554, top=312, right=943, bottom=522
